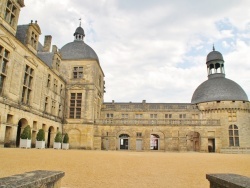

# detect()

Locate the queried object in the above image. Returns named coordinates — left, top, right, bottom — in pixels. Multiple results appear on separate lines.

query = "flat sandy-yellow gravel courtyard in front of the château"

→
left=0, top=148, right=250, bottom=188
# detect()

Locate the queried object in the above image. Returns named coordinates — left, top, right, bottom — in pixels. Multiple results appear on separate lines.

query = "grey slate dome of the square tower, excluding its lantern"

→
left=60, top=40, right=99, bottom=62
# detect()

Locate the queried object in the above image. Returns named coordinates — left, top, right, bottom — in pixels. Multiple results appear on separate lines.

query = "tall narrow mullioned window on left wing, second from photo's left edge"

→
left=21, top=65, right=34, bottom=104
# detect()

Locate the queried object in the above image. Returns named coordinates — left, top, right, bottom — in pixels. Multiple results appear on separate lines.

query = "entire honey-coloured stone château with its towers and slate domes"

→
left=0, top=0, right=250, bottom=153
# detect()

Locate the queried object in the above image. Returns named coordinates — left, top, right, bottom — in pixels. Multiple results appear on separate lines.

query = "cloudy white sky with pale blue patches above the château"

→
left=19, top=0, right=250, bottom=103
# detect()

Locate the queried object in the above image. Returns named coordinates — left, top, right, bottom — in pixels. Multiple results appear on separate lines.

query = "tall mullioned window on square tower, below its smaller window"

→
left=69, top=93, right=82, bottom=119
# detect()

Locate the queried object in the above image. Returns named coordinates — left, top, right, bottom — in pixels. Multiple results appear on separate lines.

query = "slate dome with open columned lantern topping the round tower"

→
left=191, top=47, right=248, bottom=104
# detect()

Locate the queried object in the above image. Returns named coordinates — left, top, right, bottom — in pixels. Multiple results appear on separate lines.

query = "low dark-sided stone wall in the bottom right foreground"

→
left=206, top=174, right=250, bottom=188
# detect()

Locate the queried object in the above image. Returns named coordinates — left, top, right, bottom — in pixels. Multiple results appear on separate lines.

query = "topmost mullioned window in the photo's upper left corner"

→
left=4, top=0, right=17, bottom=27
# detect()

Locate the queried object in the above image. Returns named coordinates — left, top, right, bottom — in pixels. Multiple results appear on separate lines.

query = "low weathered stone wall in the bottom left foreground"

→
left=0, top=170, right=65, bottom=188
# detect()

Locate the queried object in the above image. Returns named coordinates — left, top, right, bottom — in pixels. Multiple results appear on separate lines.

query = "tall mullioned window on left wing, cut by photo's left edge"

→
left=0, top=46, right=10, bottom=94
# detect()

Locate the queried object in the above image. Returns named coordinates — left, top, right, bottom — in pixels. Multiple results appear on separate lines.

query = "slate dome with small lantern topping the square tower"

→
left=60, top=25, right=99, bottom=62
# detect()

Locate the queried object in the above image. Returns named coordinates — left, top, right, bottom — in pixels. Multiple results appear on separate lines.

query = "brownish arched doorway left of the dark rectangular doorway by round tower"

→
left=186, top=131, right=201, bottom=151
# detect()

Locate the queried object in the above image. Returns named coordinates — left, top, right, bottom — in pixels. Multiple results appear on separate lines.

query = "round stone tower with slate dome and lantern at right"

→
left=191, top=47, right=250, bottom=153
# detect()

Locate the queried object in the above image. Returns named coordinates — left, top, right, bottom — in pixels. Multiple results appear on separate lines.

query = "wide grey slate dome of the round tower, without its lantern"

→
left=191, top=74, right=248, bottom=104
